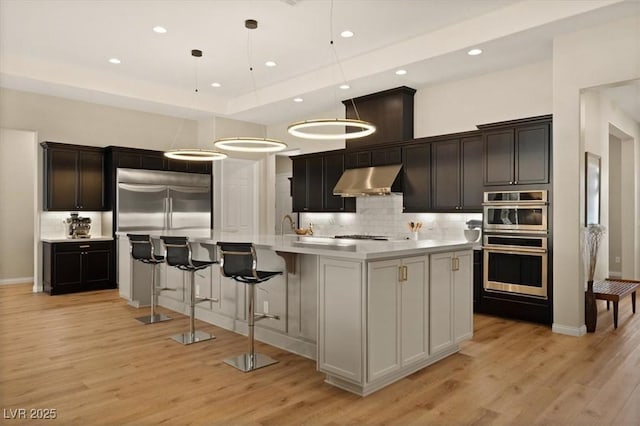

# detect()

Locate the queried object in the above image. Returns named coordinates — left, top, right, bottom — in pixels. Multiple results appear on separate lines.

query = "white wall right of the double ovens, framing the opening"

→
left=553, top=15, right=640, bottom=335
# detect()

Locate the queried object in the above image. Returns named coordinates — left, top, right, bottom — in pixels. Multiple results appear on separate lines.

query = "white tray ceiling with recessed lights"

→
left=0, top=0, right=640, bottom=124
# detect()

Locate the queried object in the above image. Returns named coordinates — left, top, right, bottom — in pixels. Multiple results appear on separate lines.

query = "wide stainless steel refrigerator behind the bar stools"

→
left=116, top=169, right=212, bottom=232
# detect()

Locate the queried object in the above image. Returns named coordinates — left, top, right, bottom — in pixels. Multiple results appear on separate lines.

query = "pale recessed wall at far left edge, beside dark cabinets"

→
left=0, top=129, right=37, bottom=284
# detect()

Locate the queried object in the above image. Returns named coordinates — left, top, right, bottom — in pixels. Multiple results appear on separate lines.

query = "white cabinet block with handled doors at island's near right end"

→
left=318, top=250, right=473, bottom=396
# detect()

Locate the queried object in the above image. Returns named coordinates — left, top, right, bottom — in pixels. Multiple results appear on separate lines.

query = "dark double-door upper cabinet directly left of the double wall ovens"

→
left=431, top=135, right=484, bottom=212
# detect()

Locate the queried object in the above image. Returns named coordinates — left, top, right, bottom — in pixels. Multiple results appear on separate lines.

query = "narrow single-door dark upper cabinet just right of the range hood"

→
left=401, top=142, right=431, bottom=213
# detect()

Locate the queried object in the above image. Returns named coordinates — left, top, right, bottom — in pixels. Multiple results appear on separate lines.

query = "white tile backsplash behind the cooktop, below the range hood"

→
left=300, top=194, right=482, bottom=240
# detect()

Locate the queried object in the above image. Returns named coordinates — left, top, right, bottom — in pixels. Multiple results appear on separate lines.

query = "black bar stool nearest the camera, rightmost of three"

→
left=218, top=242, right=282, bottom=373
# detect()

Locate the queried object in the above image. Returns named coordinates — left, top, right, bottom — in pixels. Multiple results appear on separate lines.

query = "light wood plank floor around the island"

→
left=0, top=284, right=640, bottom=425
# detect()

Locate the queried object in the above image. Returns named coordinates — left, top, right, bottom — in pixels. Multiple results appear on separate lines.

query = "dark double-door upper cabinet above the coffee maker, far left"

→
left=41, top=142, right=107, bottom=211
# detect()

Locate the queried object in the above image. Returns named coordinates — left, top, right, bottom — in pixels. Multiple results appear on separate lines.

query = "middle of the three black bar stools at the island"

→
left=160, top=236, right=218, bottom=345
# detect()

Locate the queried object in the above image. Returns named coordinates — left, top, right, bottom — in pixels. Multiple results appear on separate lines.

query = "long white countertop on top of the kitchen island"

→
left=118, top=229, right=476, bottom=260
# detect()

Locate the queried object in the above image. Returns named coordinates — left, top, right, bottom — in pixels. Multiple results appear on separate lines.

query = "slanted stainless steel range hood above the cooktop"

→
left=333, top=164, right=402, bottom=197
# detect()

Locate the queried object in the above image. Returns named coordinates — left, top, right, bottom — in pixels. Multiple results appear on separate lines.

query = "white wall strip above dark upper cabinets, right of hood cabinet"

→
left=414, top=61, right=553, bottom=138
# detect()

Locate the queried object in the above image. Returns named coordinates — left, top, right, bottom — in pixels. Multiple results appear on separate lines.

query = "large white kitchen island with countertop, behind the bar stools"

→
left=119, top=230, right=473, bottom=396
